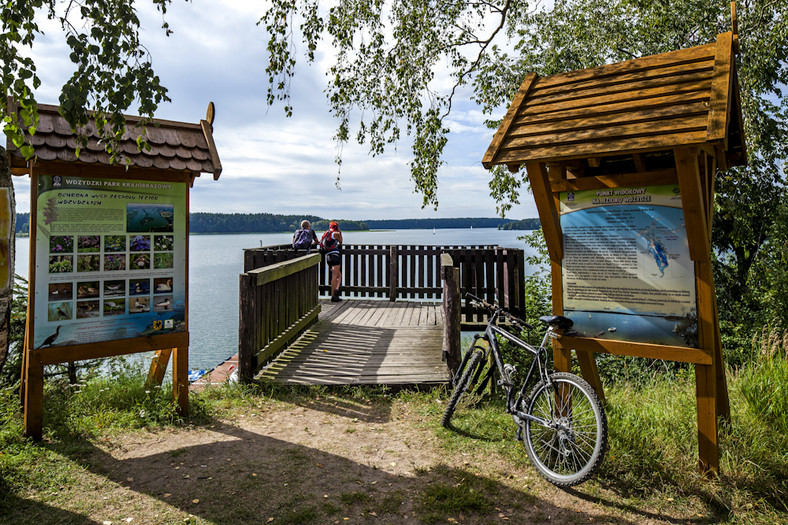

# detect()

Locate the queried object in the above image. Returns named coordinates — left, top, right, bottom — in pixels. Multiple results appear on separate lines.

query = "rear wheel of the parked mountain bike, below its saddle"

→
left=522, top=372, right=607, bottom=487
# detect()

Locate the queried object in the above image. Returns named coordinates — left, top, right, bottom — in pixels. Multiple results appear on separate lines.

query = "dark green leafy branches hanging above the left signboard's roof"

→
left=0, top=0, right=171, bottom=161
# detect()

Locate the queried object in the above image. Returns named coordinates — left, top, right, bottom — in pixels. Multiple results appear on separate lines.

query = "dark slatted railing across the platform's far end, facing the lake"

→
left=244, top=244, right=525, bottom=322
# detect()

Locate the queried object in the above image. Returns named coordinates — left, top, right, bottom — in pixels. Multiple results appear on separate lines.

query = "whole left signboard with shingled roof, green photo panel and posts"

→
left=9, top=104, right=221, bottom=439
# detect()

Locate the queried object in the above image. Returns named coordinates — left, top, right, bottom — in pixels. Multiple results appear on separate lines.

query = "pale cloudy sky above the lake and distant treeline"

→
left=14, top=0, right=537, bottom=220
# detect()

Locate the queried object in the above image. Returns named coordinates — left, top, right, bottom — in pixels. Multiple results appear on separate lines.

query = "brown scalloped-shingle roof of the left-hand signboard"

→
left=6, top=104, right=222, bottom=179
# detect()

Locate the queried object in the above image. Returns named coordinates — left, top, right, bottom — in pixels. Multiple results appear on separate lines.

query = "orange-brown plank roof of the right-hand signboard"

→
left=482, top=33, right=745, bottom=174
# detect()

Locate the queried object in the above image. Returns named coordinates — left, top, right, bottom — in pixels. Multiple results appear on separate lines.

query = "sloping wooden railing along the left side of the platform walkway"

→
left=238, top=250, right=321, bottom=380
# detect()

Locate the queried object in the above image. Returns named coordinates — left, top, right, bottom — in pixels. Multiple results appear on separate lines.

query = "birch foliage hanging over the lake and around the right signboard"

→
left=261, top=0, right=788, bottom=348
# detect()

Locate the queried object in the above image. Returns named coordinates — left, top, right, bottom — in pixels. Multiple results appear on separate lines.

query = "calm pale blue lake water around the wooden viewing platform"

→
left=16, top=228, right=529, bottom=369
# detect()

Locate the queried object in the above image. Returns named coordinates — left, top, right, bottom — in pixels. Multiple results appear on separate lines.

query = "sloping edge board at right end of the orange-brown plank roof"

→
left=706, top=32, right=736, bottom=144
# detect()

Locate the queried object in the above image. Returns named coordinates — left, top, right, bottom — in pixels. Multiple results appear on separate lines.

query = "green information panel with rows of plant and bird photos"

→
left=34, top=175, right=187, bottom=348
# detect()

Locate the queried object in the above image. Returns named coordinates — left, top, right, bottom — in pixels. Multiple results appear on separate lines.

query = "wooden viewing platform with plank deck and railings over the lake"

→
left=235, top=245, right=525, bottom=386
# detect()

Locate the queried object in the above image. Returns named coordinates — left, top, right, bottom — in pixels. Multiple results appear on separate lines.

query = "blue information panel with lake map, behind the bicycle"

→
left=560, top=185, right=697, bottom=347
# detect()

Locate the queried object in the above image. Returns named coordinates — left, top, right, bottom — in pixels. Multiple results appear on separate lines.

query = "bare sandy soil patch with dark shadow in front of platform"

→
left=15, top=392, right=704, bottom=525
